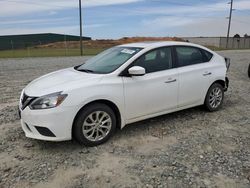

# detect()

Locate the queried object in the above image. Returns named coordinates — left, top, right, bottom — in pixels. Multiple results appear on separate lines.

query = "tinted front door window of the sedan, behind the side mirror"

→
left=134, top=47, right=172, bottom=73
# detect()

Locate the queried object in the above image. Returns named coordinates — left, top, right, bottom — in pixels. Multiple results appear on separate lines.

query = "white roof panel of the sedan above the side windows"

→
left=120, top=41, right=207, bottom=48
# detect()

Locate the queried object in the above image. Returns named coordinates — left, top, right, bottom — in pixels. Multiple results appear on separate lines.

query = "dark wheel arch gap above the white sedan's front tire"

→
left=71, top=99, right=122, bottom=138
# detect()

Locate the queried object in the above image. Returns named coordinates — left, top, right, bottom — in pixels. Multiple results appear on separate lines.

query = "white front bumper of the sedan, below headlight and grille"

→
left=19, top=106, right=77, bottom=141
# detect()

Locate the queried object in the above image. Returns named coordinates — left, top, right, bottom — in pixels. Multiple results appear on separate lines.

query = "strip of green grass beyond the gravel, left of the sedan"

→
left=0, top=48, right=104, bottom=58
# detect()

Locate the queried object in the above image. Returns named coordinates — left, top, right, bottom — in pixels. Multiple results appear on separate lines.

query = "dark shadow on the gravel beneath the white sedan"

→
left=29, top=106, right=225, bottom=152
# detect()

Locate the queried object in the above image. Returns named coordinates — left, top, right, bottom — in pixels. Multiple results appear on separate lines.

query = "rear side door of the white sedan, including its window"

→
left=175, top=46, right=212, bottom=107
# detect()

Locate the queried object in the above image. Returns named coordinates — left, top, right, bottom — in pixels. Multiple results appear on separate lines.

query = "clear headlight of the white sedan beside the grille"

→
left=29, top=92, right=68, bottom=110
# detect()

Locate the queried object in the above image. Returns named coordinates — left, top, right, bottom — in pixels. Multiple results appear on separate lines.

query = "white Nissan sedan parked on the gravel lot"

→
left=19, top=42, right=229, bottom=146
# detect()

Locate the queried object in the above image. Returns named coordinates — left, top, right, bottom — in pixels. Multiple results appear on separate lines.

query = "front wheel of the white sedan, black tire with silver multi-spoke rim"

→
left=73, top=103, right=116, bottom=147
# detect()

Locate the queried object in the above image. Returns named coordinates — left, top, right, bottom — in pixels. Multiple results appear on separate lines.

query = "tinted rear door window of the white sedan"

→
left=176, top=46, right=205, bottom=66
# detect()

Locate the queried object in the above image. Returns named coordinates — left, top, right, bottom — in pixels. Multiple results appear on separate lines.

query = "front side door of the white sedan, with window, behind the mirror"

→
left=123, top=47, right=178, bottom=122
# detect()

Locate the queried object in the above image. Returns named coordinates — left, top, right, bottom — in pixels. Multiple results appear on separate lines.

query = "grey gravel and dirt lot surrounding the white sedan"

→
left=0, top=50, right=250, bottom=188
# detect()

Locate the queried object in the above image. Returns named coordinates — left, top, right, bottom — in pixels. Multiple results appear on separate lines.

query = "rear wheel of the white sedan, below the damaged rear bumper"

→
left=204, top=83, right=224, bottom=112
